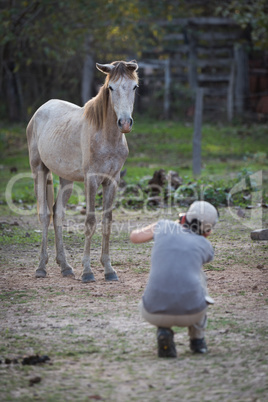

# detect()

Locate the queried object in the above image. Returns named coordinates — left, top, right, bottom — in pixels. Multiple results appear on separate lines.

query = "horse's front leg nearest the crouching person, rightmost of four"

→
left=101, top=181, right=118, bottom=281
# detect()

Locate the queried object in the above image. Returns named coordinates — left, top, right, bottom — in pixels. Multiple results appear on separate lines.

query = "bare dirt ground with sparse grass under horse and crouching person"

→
left=0, top=209, right=268, bottom=402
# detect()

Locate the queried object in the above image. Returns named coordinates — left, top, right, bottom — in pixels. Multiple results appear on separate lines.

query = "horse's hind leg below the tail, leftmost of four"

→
left=34, top=162, right=51, bottom=278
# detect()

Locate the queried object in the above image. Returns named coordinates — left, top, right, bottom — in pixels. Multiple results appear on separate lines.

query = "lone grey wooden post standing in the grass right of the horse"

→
left=193, top=88, right=204, bottom=176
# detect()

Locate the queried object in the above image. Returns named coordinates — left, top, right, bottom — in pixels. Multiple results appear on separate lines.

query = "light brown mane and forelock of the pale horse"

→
left=84, top=61, right=138, bottom=130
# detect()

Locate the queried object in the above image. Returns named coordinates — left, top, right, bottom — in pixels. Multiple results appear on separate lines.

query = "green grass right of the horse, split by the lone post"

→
left=125, top=118, right=268, bottom=182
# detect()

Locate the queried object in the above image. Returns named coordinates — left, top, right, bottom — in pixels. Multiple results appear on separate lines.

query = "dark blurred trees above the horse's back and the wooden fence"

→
left=0, top=0, right=268, bottom=121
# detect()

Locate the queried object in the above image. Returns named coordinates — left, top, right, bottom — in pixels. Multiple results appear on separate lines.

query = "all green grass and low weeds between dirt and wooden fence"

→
left=0, top=120, right=268, bottom=211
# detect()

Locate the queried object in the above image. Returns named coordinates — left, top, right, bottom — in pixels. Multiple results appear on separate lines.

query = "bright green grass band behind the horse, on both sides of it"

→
left=0, top=116, right=268, bottom=208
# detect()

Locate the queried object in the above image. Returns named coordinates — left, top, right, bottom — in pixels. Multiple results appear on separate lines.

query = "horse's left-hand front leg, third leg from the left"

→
left=82, top=174, right=98, bottom=282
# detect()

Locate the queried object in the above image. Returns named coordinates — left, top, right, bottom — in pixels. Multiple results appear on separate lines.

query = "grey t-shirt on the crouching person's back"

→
left=143, top=220, right=214, bottom=315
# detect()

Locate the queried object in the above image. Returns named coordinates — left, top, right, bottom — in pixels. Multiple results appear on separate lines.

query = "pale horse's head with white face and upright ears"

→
left=96, top=61, right=138, bottom=133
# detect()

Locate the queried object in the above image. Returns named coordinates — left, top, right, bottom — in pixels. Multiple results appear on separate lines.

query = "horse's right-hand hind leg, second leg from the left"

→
left=53, top=177, right=74, bottom=276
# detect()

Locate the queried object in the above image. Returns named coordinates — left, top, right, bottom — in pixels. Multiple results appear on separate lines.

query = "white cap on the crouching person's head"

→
left=186, top=201, right=218, bottom=232
